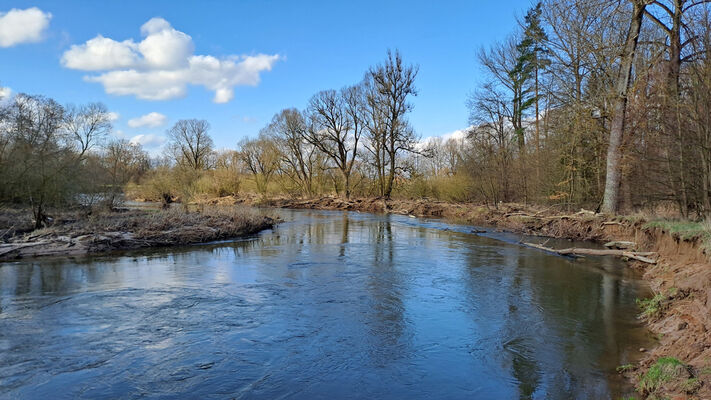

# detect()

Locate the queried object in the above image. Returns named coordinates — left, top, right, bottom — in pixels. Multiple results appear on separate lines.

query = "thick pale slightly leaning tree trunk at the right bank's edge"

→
left=601, top=0, right=647, bottom=214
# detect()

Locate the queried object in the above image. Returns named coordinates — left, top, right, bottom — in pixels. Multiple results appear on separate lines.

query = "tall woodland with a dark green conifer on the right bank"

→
left=468, top=0, right=711, bottom=216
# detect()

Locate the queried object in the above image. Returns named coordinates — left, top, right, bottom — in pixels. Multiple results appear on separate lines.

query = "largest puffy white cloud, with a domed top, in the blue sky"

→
left=61, top=18, right=280, bottom=103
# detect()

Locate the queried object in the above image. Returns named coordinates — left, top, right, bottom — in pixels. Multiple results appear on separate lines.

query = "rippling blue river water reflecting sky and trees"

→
left=0, top=210, right=647, bottom=399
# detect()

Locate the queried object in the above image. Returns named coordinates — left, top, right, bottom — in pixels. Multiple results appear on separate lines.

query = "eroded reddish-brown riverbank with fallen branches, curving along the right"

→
left=200, top=196, right=711, bottom=399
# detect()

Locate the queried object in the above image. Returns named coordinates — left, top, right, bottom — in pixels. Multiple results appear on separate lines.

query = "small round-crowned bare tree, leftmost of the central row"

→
left=167, top=119, right=213, bottom=170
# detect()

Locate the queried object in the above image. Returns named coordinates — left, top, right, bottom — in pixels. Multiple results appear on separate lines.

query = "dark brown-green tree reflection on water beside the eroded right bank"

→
left=490, top=250, right=634, bottom=398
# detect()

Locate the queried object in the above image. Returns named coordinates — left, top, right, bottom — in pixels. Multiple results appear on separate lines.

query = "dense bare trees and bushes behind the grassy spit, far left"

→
left=0, top=94, right=150, bottom=228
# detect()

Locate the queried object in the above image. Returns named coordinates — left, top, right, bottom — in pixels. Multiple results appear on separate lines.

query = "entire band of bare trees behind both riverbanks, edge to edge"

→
left=0, top=0, right=711, bottom=227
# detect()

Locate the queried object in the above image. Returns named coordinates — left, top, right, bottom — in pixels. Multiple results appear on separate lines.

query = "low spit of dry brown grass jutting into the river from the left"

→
left=0, top=207, right=276, bottom=261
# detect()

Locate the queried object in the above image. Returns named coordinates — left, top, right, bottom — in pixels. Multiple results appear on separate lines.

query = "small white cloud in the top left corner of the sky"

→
left=0, top=7, right=52, bottom=47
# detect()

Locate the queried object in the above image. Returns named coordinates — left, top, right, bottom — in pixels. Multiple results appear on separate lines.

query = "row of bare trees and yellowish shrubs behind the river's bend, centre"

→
left=137, top=51, right=419, bottom=203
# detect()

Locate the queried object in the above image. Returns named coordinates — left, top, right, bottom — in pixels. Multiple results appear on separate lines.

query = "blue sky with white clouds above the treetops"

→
left=0, top=0, right=531, bottom=152
